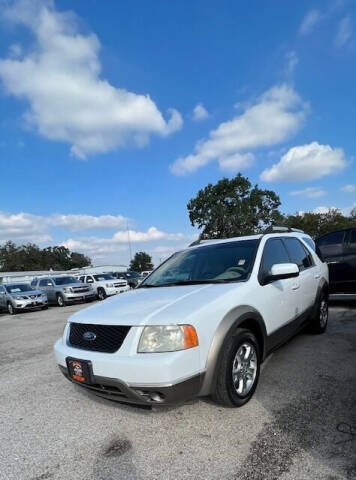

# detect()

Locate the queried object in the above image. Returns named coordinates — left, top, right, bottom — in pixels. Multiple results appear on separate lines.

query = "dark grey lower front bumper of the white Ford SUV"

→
left=58, top=365, right=203, bottom=406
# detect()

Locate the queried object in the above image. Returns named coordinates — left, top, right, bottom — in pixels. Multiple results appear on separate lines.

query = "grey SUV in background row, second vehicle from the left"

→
left=31, top=275, right=95, bottom=307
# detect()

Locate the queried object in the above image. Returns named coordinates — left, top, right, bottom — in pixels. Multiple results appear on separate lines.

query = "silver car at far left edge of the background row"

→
left=0, top=283, right=48, bottom=315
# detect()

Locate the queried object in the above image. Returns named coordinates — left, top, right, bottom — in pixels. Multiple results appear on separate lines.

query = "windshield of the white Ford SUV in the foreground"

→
left=140, top=240, right=258, bottom=288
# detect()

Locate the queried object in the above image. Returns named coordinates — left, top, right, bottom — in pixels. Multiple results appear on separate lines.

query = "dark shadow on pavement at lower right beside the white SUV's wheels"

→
left=236, top=302, right=356, bottom=480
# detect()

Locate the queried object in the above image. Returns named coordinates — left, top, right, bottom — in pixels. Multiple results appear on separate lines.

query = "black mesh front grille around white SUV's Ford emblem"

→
left=69, top=323, right=131, bottom=353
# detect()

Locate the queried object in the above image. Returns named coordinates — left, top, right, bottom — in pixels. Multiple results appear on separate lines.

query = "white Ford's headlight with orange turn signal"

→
left=137, top=325, right=199, bottom=353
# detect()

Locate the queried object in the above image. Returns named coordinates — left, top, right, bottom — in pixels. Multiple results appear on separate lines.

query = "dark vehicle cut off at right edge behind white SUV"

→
left=316, top=225, right=356, bottom=295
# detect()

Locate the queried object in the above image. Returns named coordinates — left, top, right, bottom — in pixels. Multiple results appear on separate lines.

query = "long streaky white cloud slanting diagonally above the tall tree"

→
left=171, top=85, right=307, bottom=175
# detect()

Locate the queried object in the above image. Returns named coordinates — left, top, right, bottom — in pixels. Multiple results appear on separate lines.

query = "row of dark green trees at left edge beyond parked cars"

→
left=0, top=241, right=91, bottom=272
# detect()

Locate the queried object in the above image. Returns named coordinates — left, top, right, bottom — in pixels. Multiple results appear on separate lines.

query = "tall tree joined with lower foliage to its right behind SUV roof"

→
left=187, top=173, right=356, bottom=238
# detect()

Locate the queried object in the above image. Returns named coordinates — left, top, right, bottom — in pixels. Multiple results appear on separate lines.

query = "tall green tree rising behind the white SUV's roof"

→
left=187, top=173, right=282, bottom=238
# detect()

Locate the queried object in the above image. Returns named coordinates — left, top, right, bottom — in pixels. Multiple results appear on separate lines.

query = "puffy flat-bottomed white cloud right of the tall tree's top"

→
left=261, top=142, right=347, bottom=182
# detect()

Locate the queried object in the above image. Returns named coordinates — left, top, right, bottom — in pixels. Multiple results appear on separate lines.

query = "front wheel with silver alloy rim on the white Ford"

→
left=212, top=328, right=261, bottom=408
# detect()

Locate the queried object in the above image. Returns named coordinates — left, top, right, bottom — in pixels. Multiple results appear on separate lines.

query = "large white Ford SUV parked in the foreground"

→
left=54, top=228, right=328, bottom=407
